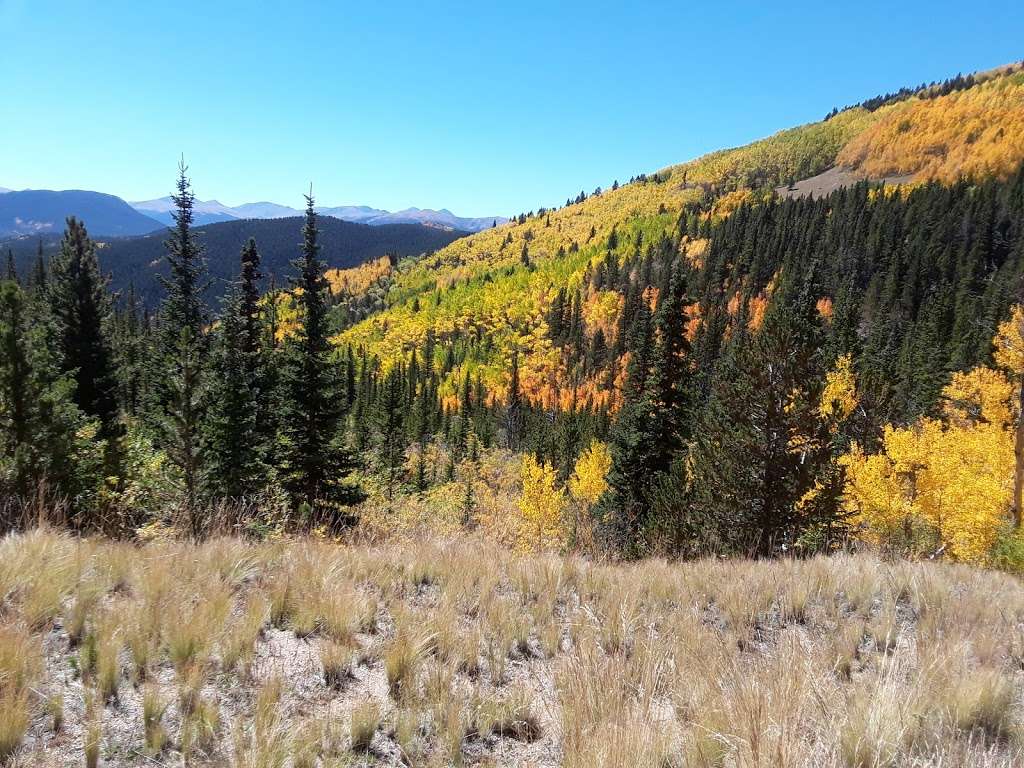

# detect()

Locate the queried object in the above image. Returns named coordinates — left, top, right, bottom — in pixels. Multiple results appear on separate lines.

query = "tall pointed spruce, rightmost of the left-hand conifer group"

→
left=280, top=194, right=362, bottom=522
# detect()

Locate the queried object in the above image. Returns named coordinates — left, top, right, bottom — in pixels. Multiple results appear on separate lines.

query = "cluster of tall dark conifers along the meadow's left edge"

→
left=0, top=168, right=380, bottom=537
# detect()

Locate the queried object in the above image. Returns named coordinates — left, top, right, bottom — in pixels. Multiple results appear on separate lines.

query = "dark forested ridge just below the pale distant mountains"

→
left=0, top=216, right=463, bottom=307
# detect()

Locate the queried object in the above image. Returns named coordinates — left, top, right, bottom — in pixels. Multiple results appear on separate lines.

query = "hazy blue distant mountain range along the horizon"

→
left=0, top=186, right=507, bottom=238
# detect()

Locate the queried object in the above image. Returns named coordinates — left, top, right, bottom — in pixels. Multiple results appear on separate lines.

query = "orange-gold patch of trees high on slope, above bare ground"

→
left=837, top=73, right=1024, bottom=181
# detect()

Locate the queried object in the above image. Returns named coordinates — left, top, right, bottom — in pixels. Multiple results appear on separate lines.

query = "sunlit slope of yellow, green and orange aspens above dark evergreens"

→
left=339, top=66, right=1024, bottom=401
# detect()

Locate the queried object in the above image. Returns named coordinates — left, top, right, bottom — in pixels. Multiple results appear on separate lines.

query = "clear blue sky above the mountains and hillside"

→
left=0, top=0, right=1024, bottom=215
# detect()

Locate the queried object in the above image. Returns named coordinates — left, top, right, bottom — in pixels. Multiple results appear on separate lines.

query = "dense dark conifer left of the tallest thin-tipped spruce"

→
left=48, top=216, right=122, bottom=454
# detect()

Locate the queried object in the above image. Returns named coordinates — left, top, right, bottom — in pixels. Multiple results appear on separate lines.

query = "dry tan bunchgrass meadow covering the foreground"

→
left=0, top=531, right=1024, bottom=768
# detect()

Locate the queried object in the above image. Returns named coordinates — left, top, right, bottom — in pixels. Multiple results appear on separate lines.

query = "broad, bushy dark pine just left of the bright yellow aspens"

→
left=692, top=296, right=830, bottom=554
